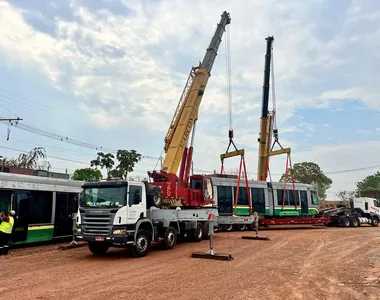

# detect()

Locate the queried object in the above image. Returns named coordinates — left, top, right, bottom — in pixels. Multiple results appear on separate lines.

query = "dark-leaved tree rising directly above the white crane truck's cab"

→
left=90, top=149, right=141, bottom=180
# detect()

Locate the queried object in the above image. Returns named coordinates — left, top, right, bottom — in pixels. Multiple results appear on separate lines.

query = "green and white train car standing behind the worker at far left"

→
left=0, top=173, right=83, bottom=245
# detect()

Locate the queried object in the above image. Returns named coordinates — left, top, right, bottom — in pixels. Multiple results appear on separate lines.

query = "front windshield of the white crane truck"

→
left=80, top=187, right=126, bottom=208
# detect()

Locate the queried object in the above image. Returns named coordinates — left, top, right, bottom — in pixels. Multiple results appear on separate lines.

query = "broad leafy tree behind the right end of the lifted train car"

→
left=280, top=162, right=332, bottom=200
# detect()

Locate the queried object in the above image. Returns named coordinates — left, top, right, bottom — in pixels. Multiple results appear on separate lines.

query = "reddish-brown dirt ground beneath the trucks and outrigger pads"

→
left=0, top=226, right=380, bottom=300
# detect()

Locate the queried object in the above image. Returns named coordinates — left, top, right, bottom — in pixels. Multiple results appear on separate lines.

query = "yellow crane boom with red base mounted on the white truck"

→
left=148, top=11, right=231, bottom=207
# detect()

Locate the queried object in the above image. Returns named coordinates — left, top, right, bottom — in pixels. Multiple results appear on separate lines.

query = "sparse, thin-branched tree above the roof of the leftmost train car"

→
left=2, top=147, right=51, bottom=170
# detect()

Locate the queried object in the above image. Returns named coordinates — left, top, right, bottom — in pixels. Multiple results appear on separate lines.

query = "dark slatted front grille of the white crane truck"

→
left=80, top=209, right=115, bottom=236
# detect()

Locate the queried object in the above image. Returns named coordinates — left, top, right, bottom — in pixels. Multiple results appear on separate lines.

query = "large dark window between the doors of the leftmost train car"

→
left=29, top=191, right=53, bottom=224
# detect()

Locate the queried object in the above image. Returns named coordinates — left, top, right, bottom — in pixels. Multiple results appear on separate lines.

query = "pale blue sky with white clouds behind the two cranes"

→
left=0, top=0, right=380, bottom=200
